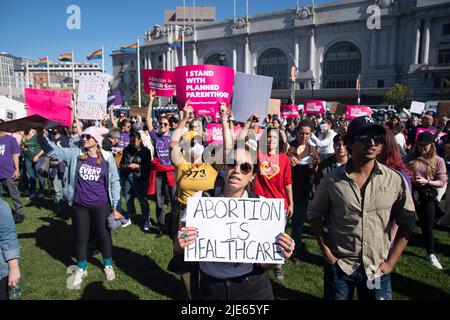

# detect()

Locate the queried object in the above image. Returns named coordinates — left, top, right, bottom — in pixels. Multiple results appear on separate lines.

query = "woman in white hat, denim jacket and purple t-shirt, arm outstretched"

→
left=40, top=127, right=121, bottom=287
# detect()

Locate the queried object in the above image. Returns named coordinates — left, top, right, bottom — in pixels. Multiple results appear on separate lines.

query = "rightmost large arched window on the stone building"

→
left=323, top=42, right=361, bottom=88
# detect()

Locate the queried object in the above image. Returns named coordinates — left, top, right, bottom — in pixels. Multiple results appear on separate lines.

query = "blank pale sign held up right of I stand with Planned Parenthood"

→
left=232, top=72, right=273, bottom=122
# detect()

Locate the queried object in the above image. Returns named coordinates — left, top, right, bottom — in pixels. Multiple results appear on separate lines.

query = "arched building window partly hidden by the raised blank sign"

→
left=257, top=49, right=289, bottom=89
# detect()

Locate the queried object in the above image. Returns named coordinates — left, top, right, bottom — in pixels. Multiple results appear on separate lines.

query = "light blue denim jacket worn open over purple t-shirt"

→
left=44, top=139, right=120, bottom=208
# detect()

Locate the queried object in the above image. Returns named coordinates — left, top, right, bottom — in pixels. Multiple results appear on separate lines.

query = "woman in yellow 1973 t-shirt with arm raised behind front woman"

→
left=166, top=101, right=221, bottom=299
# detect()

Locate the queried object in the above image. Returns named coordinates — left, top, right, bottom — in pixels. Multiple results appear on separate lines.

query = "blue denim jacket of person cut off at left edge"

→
left=0, top=199, right=20, bottom=279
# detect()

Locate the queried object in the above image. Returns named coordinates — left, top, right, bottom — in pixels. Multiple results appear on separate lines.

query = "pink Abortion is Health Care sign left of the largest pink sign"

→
left=142, top=69, right=175, bottom=97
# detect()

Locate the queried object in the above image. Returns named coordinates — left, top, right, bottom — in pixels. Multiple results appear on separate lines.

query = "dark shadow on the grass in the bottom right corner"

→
left=391, top=273, right=450, bottom=300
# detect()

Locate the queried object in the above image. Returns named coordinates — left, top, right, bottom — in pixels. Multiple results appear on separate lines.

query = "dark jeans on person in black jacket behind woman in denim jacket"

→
left=124, top=173, right=150, bottom=221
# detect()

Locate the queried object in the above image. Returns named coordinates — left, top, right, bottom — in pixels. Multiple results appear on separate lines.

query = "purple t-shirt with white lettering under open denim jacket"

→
left=73, top=156, right=108, bottom=207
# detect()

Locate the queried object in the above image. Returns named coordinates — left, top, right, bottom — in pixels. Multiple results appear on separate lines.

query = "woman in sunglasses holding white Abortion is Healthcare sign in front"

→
left=175, top=104, right=295, bottom=300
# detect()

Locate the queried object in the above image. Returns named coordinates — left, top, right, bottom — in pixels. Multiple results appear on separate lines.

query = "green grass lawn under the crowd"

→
left=3, top=194, right=450, bottom=300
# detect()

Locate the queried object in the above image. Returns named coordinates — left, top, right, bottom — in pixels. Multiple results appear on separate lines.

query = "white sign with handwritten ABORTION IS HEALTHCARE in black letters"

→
left=184, top=197, right=285, bottom=264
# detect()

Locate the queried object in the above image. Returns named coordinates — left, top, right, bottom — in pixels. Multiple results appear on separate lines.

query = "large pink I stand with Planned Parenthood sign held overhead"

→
left=175, top=65, right=234, bottom=115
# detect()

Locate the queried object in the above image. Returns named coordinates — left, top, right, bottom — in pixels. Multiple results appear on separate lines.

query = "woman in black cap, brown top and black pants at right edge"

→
left=405, top=132, right=448, bottom=270
